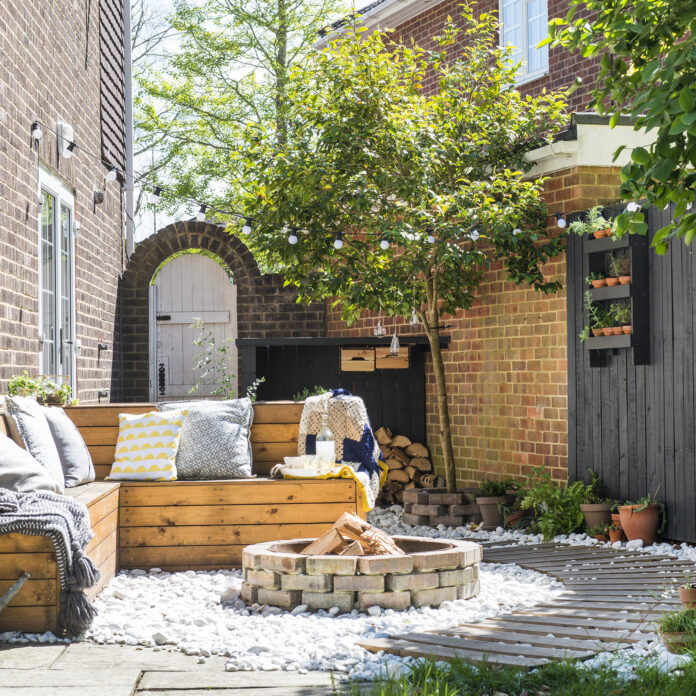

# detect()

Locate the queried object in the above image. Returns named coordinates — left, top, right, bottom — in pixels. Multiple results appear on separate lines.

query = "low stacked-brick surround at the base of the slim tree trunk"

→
left=403, top=488, right=481, bottom=527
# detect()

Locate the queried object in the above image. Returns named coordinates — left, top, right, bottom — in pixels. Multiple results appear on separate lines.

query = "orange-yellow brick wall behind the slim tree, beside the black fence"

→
left=327, top=167, right=619, bottom=485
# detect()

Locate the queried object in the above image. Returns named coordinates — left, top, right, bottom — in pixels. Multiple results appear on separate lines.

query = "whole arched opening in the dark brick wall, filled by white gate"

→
left=149, top=248, right=237, bottom=401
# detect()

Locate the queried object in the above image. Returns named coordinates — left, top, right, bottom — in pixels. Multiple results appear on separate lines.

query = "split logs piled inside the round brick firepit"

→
left=301, top=512, right=403, bottom=556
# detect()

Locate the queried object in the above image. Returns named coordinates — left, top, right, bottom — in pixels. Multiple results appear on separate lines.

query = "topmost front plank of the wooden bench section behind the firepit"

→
left=121, top=479, right=356, bottom=507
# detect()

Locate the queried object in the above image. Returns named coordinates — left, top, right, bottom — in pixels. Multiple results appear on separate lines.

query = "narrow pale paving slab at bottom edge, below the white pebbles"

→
left=138, top=670, right=339, bottom=696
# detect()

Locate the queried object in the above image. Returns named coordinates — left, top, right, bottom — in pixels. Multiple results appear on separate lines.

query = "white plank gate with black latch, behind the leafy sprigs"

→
left=150, top=254, right=237, bottom=401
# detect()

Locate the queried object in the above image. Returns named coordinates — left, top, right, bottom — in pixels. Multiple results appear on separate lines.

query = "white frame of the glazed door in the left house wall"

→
left=37, top=165, right=77, bottom=396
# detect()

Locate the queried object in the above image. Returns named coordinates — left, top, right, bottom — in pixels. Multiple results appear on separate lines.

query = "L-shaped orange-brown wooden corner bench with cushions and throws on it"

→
left=0, top=402, right=363, bottom=633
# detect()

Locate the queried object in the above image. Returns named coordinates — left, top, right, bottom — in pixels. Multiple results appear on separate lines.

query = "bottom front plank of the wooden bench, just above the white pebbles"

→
left=117, top=544, right=244, bottom=572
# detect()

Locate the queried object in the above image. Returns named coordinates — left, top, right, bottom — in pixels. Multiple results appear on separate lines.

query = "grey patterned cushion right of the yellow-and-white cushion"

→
left=157, top=399, right=254, bottom=480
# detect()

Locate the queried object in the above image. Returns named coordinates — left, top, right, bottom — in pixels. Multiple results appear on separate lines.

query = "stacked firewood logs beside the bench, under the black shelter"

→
left=375, top=428, right=444, bottom=505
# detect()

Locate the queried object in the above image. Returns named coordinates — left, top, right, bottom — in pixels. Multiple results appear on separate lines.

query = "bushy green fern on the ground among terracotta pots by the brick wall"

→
left=521, top=466, right=596, bottom=541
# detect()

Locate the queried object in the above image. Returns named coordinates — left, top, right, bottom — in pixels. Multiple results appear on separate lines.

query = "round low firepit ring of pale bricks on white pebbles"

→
left=242, top=536, right=481, bottom=613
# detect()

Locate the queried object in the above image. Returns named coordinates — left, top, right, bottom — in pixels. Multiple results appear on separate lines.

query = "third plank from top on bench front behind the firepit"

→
left=119, top=519, right=336, bottom=549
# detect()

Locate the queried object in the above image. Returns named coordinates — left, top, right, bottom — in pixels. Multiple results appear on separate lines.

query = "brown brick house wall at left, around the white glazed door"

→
left=0, top=0, right=124, bottom=401
